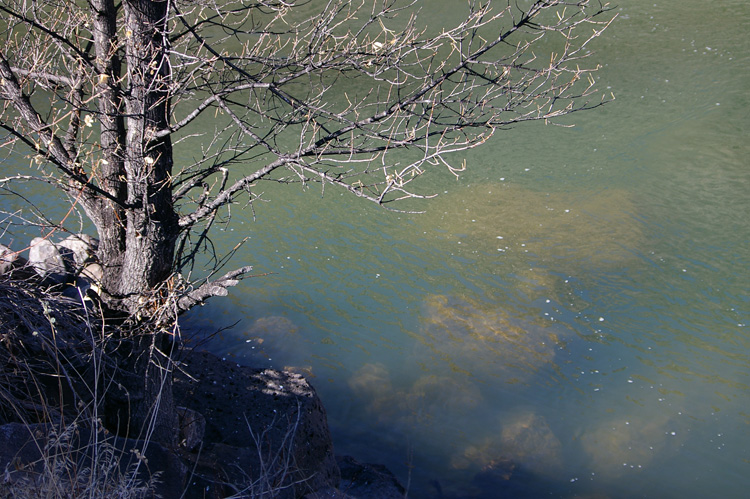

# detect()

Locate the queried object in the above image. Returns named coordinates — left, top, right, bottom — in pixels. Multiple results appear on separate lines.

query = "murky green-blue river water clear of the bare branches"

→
left=1, top=0, right=750, bottom=498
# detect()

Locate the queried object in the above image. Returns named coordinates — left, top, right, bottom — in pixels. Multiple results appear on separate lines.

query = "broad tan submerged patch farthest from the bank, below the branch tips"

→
left=416, top=183, right=644, bottom=272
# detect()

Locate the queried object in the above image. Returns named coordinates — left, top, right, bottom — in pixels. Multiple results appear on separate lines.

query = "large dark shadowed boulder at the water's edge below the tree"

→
left=173, top=351, right=340, bottom=498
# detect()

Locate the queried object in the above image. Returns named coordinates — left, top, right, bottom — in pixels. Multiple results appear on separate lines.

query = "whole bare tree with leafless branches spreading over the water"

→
left=0, top=0, right=611, bottom=316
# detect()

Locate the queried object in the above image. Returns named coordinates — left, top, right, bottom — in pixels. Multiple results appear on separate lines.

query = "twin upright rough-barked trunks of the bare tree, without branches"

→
left=93, top=0, right=179, bottom=315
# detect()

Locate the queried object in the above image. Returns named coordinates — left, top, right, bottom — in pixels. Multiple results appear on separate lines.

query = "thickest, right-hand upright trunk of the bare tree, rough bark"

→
left=116, top=0, right=179, bottom=296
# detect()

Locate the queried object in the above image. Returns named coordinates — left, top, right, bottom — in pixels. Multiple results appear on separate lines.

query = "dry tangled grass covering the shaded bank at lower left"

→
left=0, top=276, right=157, bottom=498
